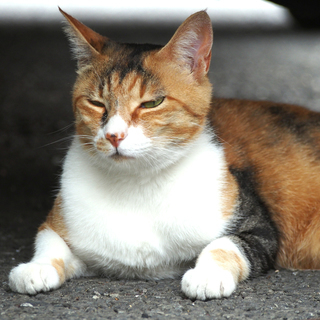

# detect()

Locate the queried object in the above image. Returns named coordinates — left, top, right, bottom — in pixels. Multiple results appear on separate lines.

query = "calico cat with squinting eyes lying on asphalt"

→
left=9, top=10, right=320, bottom=300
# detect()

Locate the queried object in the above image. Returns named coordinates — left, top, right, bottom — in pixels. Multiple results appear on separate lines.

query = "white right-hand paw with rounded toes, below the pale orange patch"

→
left=181, top=268, right=236, bottom=300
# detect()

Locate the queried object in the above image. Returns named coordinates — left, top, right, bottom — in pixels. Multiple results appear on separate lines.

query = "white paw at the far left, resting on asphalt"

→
left=9, top=262, right=60, bottom=294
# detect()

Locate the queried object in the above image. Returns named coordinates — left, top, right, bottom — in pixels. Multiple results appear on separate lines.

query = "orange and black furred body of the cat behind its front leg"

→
left=210, top=99, right=320, bottom=268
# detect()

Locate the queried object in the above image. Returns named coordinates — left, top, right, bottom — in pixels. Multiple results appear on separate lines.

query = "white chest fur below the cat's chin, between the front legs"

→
left=61, top=136, right=228, bottom=278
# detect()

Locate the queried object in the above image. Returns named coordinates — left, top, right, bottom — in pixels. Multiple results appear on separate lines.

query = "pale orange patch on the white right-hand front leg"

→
left=211, top=249, right=249, bottom=282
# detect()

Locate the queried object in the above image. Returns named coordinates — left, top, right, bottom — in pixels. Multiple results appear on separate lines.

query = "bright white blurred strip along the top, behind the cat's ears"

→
left=0, top=0, right=289, bottom=25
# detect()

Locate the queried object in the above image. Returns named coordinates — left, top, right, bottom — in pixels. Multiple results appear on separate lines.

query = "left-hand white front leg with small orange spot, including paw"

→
left=9, top=228, right=85, bottom=295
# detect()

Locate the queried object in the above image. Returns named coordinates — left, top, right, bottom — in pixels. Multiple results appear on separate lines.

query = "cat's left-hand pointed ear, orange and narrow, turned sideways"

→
left=59, top=8, right=109, bottom=68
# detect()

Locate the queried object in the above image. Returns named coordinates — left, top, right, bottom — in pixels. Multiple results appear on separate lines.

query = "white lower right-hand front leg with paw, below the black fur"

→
left=181, top=237, right=250, bottom=300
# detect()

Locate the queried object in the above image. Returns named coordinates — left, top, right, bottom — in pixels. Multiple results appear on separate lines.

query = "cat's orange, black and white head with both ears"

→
left=61, top=10, right=212, bottom=170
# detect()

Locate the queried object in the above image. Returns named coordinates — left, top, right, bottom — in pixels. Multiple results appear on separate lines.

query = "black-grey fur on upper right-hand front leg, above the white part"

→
left=229, top=168, right=279, bottom=277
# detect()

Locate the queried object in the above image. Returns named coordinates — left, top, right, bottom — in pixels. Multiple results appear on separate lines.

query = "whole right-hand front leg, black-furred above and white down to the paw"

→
left=182, top=169, right=279, bottom=300
